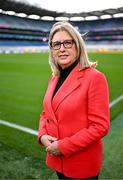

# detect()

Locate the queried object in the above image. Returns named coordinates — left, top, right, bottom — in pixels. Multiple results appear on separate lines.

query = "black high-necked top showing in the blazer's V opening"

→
left=53, top=61, right=78, bottom=97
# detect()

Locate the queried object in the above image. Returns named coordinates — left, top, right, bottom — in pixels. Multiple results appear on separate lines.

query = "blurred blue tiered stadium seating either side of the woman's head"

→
left=0, top=14, right=123, bottom=46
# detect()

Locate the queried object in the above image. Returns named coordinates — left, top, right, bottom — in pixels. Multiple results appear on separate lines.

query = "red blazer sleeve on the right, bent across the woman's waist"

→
left=58, top=72, right=110, bottom=157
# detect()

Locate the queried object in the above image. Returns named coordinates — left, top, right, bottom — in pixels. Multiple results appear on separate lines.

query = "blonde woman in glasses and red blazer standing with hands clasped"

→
left=39, top=22, right=109, bottom=179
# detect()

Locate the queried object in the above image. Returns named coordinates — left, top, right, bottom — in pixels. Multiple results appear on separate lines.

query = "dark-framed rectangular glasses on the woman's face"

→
left=50, top=39, right=75, bottom=50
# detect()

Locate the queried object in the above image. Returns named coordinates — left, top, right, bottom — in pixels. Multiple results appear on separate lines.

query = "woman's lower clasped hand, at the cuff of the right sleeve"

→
left=46, top=141, right=62, bottom=156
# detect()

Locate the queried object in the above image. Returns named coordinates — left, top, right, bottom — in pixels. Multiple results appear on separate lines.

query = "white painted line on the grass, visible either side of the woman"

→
left=0, top=94, right=123, bottom=136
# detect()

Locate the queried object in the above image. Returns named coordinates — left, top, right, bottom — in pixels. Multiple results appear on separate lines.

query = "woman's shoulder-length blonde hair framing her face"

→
left=49, top=22, right=96, bottom=75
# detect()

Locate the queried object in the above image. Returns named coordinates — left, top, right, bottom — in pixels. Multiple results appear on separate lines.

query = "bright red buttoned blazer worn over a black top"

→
left=39, top=65, right=109, bottom=178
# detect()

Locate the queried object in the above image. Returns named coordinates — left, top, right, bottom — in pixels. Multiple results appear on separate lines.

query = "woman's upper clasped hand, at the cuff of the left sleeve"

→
left=40, top=135, right=57, bottom=147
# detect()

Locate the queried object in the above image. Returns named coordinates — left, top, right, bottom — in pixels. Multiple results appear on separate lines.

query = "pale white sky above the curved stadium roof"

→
left=16, top=0, right=123, bottom=13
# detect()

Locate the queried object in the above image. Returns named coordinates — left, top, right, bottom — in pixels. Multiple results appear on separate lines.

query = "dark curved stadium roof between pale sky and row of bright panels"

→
left=0, top=0, right=123, bottom=18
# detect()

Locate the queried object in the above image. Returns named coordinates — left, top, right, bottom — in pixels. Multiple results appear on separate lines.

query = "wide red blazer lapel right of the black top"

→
left=52, top=65, right=84, bottom=112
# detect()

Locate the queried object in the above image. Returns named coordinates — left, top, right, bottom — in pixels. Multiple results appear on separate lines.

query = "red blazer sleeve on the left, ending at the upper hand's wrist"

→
left=38, top=111, right=47, bottom=145
